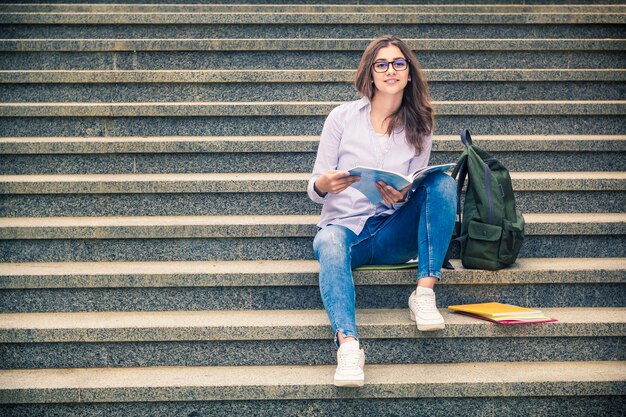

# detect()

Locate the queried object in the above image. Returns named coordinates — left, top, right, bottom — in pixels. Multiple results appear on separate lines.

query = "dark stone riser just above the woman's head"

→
left=0, top=22, right=624, bottom=39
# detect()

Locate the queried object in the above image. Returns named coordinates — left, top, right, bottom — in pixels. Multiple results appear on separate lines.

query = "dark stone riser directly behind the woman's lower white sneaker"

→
left=0, top=336, right=626, bottom=369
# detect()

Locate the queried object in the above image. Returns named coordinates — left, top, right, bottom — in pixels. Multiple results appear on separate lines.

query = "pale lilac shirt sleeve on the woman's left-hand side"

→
left=307, top=108, right=343, bottom=204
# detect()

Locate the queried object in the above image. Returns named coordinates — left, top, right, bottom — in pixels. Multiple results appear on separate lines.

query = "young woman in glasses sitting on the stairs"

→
left=308, top=35, right=456, bottom=387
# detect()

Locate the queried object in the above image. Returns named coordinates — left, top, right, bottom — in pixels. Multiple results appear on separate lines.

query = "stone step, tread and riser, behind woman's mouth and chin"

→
left=0, top=69, right=626, bottom=103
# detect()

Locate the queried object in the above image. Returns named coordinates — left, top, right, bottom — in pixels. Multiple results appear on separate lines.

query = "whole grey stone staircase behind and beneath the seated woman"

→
left=0, top=0, right=626, bottom=417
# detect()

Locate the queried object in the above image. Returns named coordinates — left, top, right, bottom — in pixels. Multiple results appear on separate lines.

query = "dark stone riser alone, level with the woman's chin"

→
left=0, top=81, right=626, bottom=103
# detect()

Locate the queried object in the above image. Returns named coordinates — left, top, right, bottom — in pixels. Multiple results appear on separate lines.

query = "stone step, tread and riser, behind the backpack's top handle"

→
left=0, top=135, right=626, bottom=175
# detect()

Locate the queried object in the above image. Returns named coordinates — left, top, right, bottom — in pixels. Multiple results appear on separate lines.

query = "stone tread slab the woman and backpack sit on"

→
left=0, top=258, right=626, bottom=289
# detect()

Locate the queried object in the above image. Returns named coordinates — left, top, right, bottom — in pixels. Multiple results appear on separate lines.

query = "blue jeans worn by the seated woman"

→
left=313, top=173, right=457, bottom=343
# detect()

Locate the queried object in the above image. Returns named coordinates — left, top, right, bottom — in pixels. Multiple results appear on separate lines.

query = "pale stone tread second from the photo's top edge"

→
left=0, top=10, right=626, bottom=24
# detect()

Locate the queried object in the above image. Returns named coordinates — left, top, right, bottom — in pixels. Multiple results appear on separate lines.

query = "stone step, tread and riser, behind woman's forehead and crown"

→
left=0, top=38, right=626, bottom=71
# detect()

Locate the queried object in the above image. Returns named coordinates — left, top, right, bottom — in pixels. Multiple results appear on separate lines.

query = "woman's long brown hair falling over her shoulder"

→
left=354, top=35, right=435, bottom=154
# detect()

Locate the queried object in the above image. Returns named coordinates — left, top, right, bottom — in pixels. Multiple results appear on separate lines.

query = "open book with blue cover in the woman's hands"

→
left=349, top=164, right=456, bottom=204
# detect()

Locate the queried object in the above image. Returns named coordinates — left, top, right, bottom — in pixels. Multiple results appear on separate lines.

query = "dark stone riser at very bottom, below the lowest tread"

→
left=0, top=394, right=626, bottom=417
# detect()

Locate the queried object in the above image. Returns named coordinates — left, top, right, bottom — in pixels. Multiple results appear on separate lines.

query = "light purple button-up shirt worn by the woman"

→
left=307, top=97, right=432, bottom=235
